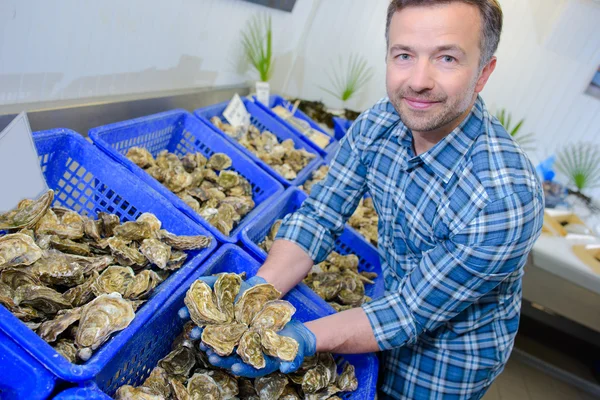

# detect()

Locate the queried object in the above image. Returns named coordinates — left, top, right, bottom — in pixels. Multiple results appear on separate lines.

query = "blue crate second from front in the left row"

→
left=89, top=110, right=283, bottom=243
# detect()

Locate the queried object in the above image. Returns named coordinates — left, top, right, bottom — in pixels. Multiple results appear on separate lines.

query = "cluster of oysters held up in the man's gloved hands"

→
left=184, top=273, right=298, bottom=369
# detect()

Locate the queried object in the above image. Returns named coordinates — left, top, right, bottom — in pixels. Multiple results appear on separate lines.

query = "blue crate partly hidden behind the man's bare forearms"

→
left=242, top=188, right=385, bottom=310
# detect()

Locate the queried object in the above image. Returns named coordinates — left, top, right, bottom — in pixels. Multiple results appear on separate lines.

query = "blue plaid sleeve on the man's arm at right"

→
left=363, top=192, right=543, bottom=350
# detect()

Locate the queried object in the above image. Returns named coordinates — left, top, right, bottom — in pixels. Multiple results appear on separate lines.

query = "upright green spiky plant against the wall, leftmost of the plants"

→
left=242, top=15, right=273, bottom=82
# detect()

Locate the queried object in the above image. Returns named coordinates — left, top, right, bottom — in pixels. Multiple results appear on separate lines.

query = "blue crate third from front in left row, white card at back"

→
left=194, top=98, right=321, bottom=187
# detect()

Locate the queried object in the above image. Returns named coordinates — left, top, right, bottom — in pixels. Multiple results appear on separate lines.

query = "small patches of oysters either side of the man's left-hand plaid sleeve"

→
left=300, top=165, right=379, bottom=247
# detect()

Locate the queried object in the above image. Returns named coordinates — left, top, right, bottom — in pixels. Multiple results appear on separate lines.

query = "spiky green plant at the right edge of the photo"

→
left=556, top=142, right=600, bottom=192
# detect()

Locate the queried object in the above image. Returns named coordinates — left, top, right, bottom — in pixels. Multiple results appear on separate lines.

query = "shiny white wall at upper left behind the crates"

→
left=0, top=0, right=313, bottom=105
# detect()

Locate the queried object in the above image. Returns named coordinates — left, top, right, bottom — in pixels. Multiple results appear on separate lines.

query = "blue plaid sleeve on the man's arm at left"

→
left=277, top=119, right=367, bottom=263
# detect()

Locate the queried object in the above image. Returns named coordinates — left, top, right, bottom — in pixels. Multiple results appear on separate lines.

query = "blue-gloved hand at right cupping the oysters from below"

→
left=207, top=320, right=317, bottom=378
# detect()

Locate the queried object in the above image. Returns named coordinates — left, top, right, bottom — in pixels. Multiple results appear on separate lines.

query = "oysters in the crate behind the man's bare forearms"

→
left=259, top=220, right=377, bottom=312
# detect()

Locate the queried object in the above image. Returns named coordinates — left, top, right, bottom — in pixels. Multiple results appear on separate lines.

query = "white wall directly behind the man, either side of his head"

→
left=286, top=0, right=600, bottom=166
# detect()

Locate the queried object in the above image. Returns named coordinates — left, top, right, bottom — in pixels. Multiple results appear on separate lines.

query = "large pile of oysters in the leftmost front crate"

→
left=0, top=191, right=211, bottom=363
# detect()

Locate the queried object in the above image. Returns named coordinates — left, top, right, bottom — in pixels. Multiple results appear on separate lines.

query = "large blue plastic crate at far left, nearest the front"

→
left=0, top=129, right=217, bottom=390
